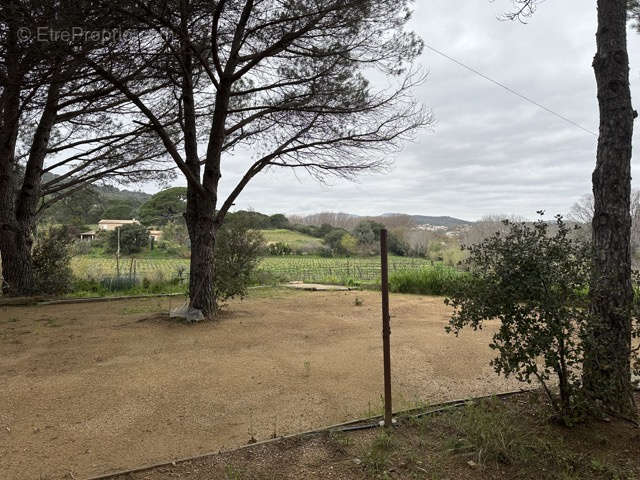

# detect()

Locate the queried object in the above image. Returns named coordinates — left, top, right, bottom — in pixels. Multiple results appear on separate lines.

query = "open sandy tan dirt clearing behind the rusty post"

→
left=0, top=290, right=521, bottom=480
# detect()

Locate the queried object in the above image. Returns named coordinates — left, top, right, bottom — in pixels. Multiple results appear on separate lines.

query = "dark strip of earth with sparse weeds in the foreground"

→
left=113, top=392, right=640, bottom=480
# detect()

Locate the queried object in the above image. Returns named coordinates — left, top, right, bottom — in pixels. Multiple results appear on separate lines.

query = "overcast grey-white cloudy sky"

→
left=169, top=0, right=640, bottom=220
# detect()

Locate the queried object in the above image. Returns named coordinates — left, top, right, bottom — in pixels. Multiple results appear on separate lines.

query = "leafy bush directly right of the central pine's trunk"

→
left=213, top=218, right=264, bottom=308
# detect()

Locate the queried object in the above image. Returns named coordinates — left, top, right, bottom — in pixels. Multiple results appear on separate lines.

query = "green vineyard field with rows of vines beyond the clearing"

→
left=71, top=255, right=430, bottom=284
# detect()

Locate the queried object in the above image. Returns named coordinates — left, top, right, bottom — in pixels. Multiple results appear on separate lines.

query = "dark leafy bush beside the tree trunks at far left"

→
left=32, top=227, right=73, bottom=295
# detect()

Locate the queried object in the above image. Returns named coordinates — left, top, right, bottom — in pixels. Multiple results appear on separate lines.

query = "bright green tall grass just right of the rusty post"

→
left=389, top=265, right=469, bottom=295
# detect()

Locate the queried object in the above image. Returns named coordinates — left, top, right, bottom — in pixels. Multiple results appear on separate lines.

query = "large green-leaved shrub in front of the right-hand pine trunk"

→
left=446, top=216, right=591, bottom=421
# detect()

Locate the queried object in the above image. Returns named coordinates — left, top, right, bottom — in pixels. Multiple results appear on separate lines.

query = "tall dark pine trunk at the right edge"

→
left=583, top=0, right=635, bottom=415
